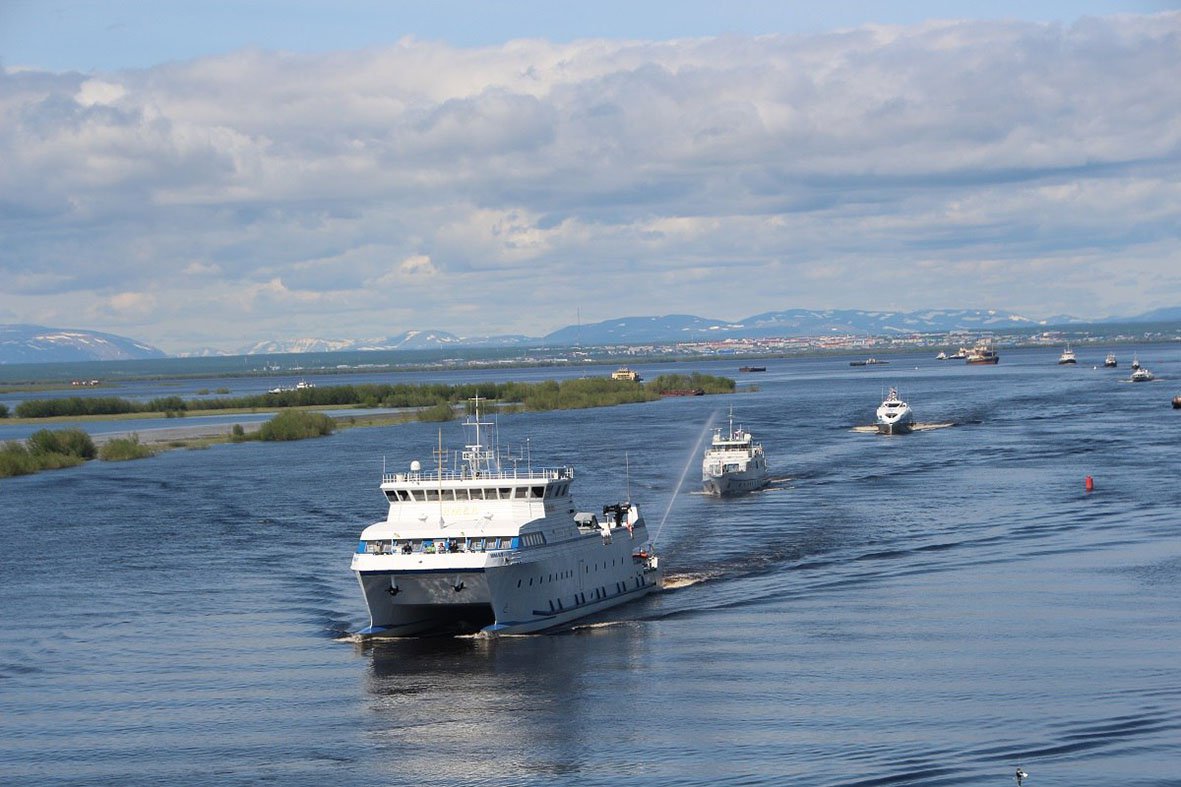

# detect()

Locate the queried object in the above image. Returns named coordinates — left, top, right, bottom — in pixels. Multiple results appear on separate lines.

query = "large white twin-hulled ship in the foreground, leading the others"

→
left=352, top=398, right=660, bottom=637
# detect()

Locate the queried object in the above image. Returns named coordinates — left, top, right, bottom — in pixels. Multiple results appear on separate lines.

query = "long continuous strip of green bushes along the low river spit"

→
left=17, top=375, right=735, bottom=418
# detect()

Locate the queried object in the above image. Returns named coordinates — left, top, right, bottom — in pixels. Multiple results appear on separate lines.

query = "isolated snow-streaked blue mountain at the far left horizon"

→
left=0, top=325, right=167, bottom=364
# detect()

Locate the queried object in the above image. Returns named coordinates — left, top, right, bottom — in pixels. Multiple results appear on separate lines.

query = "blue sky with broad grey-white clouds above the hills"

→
left=0, top=0, right=1181, bottom=352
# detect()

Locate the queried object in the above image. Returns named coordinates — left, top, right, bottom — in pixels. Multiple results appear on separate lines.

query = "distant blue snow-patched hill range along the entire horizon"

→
left=0, top=307, right=1181, bottom=364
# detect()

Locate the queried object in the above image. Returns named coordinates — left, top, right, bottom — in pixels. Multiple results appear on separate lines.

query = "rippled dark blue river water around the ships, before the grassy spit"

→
left=0, top=346, right=1181, bottom=787
